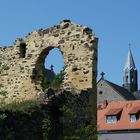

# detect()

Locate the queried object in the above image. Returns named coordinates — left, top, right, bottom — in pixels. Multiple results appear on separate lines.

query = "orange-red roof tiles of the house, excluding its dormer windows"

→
left=97, top=100, right=140, bottom=131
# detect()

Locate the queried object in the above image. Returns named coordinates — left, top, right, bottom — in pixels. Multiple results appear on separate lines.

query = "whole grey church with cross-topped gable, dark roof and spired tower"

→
left=97, top=48, right=140, bottom=103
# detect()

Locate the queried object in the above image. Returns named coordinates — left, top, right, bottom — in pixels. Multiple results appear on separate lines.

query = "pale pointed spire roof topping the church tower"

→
left=124, top=48, right=136, bottom=70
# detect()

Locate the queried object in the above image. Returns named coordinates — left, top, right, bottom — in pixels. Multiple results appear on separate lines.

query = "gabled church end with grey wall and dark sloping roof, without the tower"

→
left=97, top=78, right=136, bottom=103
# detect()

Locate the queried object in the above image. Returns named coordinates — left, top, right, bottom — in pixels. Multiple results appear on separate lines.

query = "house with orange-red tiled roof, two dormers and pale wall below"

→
left=97, top=100, right=140, bottom=140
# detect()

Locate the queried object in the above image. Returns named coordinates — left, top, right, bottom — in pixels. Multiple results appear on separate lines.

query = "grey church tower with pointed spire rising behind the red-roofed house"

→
left=123, top=48, right=138, bottom=92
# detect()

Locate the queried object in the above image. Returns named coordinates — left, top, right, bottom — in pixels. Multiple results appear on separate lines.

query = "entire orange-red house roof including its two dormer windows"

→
left=97, top=100, right=140, bottom=131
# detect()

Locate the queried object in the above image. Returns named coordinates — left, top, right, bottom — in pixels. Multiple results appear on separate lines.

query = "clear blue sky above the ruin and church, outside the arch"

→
left=0, top=0, right=140, bottom=87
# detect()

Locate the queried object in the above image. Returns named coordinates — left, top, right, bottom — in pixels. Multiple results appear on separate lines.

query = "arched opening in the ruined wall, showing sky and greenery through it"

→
left=43, top=48, right=64, bottom=89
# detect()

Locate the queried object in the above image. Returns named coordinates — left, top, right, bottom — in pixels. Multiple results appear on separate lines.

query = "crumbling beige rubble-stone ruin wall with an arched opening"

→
left=0, top=20, right=98, bottom=103
